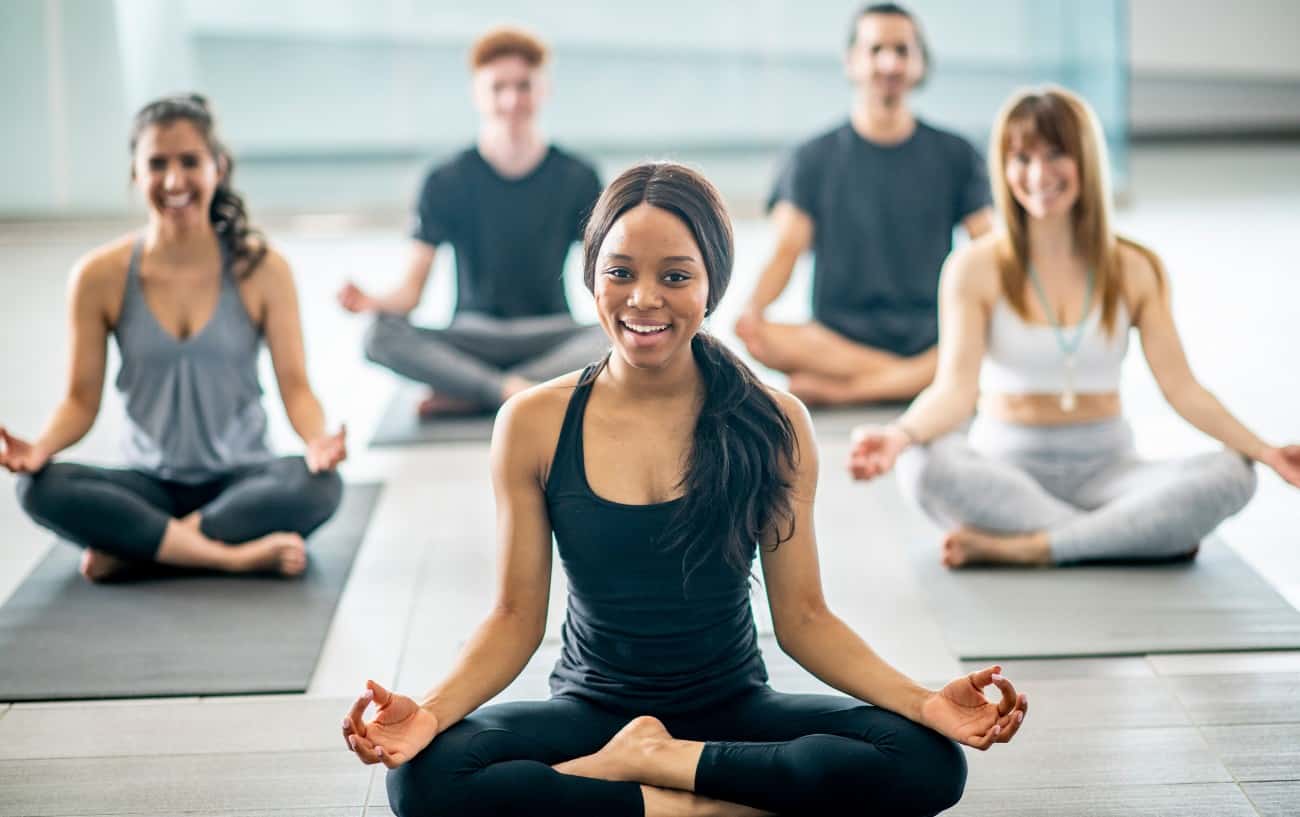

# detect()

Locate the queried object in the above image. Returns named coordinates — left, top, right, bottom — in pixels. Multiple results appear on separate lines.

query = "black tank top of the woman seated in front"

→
left=546, top=369, right=767, bottom=714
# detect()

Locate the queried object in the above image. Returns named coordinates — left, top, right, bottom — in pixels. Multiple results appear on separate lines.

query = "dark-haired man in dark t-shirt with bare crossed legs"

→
left=736, top=4, right=992, bottom=405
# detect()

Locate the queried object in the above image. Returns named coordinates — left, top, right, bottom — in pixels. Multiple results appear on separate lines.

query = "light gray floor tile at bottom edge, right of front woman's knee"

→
left=944, top=783, right=1256, bottom=817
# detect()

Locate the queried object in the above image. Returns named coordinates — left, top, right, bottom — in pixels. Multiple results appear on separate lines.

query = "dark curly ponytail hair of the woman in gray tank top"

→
left=130, top=94, right=267, bottom=278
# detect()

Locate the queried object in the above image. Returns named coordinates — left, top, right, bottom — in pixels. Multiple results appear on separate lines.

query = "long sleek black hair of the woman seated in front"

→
left=582, top=161, right=797, bottom=585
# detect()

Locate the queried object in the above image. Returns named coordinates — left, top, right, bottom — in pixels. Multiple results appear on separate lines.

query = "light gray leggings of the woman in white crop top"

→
left=897, top=416, right=1256, bottom=563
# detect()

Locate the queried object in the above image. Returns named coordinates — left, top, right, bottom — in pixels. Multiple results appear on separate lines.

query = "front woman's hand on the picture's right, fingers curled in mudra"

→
left=920, top=666, right=1030, bottom=751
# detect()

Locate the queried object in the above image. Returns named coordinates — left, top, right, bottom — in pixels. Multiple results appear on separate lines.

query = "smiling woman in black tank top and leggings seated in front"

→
left=343, top=164, right=1027, bottom=817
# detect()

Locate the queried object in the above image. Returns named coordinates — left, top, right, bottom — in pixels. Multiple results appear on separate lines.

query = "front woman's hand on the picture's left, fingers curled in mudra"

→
left=343, top=680, right=438, bottom=769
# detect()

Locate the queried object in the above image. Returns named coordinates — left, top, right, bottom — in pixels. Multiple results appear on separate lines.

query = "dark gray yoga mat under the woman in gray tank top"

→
left=0, top=483, right=382, bottom=701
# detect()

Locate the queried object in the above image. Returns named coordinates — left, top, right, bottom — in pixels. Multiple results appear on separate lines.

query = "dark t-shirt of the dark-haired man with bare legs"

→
left=768, top=121, right=989, bottom=355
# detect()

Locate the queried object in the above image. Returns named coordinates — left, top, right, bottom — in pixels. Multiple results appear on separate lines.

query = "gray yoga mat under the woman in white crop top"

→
left=910, top=536, right=1300, bottom=660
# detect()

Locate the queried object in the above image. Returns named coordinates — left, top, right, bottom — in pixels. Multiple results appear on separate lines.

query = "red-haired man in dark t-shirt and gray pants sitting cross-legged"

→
left=339, top=29, right=608, bottom=416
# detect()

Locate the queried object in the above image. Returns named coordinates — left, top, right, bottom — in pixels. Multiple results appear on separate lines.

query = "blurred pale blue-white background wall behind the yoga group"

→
left=0, top=0, right=1300, bottom=219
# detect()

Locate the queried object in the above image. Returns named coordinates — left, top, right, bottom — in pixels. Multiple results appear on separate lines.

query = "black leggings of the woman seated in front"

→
left=387, top=687, right=966, bottom=817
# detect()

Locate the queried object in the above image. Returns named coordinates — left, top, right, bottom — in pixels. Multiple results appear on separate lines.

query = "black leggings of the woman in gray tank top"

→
left=18, top=457, right=343, bottom=562
